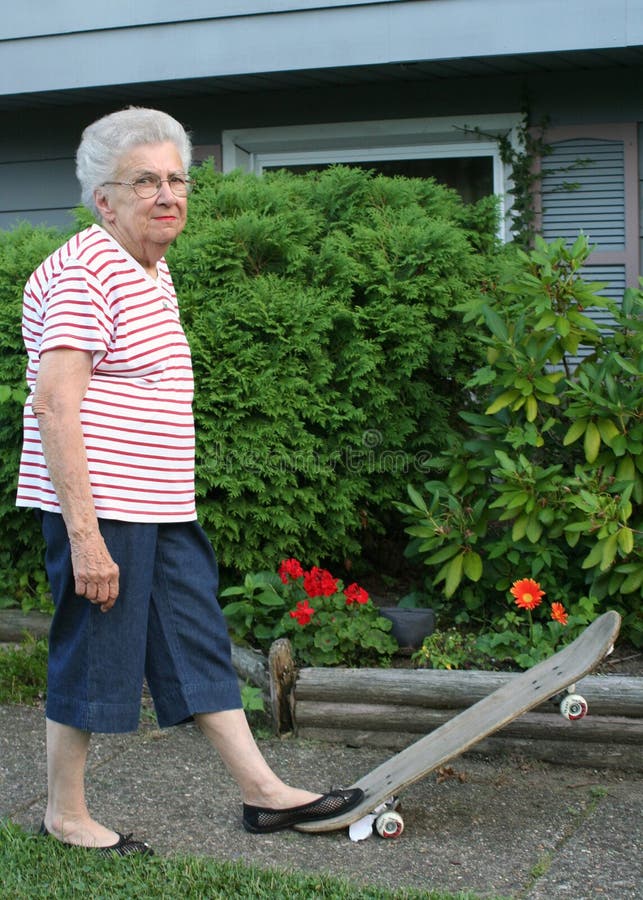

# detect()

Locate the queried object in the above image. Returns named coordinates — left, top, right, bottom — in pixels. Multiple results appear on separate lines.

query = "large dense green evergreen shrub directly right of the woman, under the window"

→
left=169, top=167, right=495, bottom=571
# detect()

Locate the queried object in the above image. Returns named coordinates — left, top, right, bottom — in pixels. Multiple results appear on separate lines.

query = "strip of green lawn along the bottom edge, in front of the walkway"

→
left=0, top=821, right=474, bottom=900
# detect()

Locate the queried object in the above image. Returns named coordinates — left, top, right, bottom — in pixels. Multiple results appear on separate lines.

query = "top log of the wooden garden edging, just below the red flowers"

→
left=295, top=668, right=643, bottom=718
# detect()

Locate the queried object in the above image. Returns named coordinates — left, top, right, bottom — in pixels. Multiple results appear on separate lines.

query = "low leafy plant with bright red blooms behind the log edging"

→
left=221, top=559, right=398, bottom=666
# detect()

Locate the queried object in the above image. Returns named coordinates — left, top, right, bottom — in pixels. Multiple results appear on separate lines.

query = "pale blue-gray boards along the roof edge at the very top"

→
left=0, top=0, right=643, bottom=94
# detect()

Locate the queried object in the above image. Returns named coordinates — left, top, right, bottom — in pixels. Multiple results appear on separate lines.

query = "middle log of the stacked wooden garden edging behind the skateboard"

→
left=295, top=700, right=643, bottom=747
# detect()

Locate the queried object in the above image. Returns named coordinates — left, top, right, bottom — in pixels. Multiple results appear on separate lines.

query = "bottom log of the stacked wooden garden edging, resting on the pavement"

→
left=298, top=726, right=643, bottom=775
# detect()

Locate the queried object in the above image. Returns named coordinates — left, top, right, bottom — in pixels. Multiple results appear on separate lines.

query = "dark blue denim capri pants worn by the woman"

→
left=39, top=512, right=241, bottom=732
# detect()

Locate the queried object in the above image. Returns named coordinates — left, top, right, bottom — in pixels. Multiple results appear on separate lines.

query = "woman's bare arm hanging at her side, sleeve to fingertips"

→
left=33, top=349, right=119, bottom=612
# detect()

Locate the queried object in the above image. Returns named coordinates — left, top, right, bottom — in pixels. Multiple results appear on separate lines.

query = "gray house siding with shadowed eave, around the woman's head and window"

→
left=0, top=0, right=643, bottom=284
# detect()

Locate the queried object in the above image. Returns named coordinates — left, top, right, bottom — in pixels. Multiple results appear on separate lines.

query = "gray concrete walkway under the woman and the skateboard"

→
left=0, top=706, right=643, bottom=900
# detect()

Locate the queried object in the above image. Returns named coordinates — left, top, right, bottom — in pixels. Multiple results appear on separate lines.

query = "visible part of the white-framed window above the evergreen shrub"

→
left=223, top=114, right=520, bottom=240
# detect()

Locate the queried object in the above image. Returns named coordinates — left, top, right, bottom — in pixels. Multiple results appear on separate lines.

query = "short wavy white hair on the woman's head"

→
left=76, top=106, right=192, bottom=215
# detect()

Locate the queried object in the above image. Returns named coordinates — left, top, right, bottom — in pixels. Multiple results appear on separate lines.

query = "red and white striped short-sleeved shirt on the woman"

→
left=16, top=225, right=196, bottom=522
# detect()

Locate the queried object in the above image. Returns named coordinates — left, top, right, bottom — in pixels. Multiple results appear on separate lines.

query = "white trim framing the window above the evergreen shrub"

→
left=222, top=113, right=522, bottom=241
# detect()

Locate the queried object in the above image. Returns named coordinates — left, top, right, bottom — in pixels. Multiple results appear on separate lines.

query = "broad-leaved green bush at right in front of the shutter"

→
left=398, top=236, right=643, bottom=653
